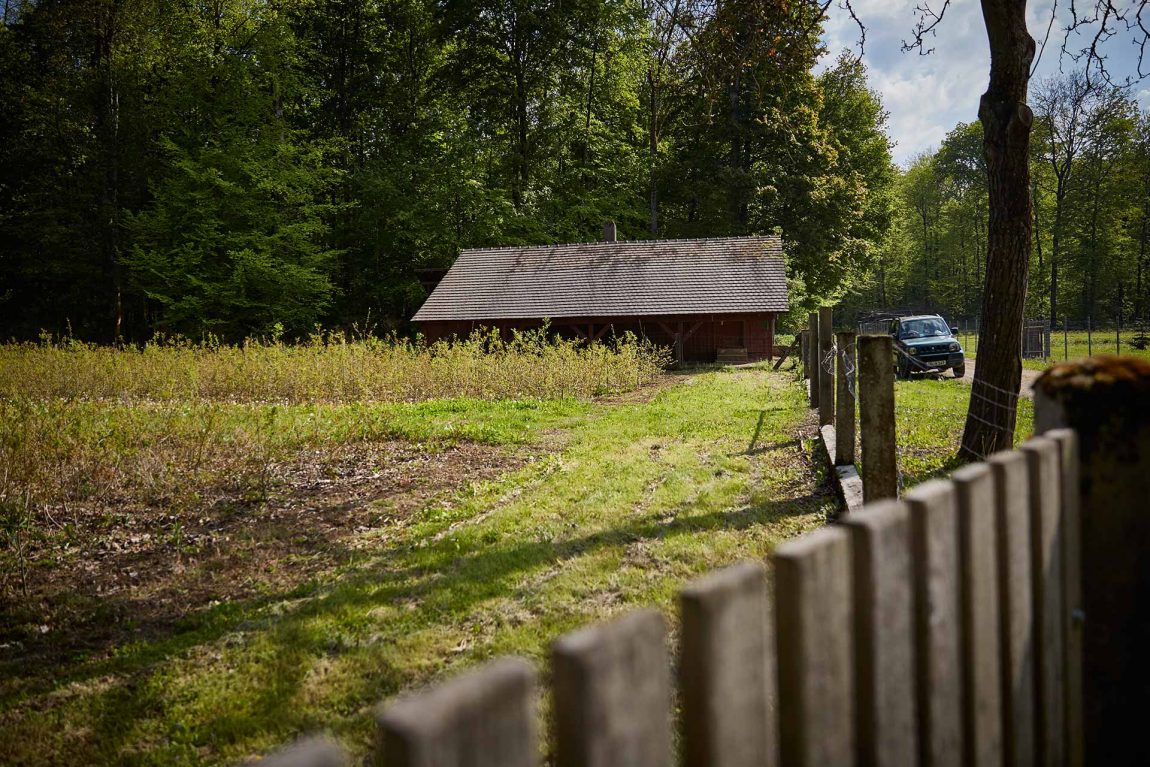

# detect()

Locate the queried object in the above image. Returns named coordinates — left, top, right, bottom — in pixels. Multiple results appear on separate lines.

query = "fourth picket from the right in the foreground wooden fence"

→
left=951, top=463, right=1003, bottom=767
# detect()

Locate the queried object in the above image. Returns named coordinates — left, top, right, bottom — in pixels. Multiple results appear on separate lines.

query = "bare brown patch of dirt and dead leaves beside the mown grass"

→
left=0, top=442, right=532, bottom=692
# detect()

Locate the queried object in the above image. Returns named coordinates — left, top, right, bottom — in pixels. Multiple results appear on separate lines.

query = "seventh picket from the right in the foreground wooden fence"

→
left=773, top=527, right=856, bottom=767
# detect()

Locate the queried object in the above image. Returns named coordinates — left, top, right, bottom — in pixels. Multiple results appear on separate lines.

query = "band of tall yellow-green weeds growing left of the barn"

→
left=0, top=329, right=669, bottom=402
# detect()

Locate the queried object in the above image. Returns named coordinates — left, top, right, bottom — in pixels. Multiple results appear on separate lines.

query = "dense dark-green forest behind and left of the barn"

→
left=0, top=0, right=892, bottom=342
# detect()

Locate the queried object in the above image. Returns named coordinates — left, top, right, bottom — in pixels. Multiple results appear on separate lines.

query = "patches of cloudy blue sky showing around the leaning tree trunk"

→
left=826, top=0, right=1150, bottom=167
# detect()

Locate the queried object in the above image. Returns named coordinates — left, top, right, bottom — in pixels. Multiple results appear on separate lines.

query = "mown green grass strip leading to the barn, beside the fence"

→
left=0, top=367, right=835, bottom=765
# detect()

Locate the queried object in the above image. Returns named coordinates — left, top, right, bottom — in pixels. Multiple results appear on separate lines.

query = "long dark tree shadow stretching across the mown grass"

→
left=11, top=480, right=826, bottom=761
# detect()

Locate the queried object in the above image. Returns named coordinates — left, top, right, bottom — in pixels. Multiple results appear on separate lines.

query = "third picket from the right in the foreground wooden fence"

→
left=987, top=451, right=1035, bottom=767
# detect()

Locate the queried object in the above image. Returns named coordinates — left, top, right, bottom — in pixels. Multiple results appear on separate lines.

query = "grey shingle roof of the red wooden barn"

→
left=414, top=236, right=788, bottom=322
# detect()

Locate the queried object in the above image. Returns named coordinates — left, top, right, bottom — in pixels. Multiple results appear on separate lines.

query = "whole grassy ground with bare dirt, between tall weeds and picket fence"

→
left=0, top=348, right=835, bottom=765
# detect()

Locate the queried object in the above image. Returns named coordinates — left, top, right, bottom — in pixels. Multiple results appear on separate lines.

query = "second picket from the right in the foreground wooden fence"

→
left=1021, top=437, right=1066, bottom=767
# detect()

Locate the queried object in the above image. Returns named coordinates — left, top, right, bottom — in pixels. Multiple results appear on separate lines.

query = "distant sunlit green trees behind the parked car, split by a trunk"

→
left=849, top=72, right=1150, bottom=327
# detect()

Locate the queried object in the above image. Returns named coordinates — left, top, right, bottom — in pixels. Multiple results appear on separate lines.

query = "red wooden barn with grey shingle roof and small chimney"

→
left=414, top=224, right=788, bottom=362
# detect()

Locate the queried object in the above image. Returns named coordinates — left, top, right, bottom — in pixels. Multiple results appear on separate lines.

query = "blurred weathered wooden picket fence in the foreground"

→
left=264, top=429, right=1082, bottom=767
